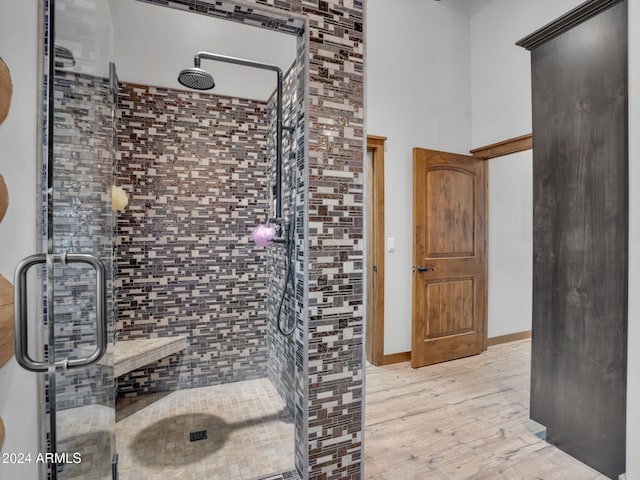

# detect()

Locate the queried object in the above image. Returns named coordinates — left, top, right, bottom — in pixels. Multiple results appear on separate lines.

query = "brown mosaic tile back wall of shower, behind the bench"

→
left=117, top=83, right=268, bottom=396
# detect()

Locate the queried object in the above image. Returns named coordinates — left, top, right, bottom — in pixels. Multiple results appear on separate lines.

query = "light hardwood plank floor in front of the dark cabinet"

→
left=364, top=340, right=606, bottom=480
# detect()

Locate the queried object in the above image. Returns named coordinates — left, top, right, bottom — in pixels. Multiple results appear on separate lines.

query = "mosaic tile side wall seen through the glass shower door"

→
left=53, top=70, right=114, bottom=410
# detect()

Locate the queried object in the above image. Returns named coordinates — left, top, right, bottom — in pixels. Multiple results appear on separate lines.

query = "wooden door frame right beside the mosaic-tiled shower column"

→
left=365, top=135, right=387, bottom=366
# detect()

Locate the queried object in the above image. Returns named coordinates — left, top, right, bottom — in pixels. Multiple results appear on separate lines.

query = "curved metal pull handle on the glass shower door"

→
left=14, top=253, right=107, bottom=372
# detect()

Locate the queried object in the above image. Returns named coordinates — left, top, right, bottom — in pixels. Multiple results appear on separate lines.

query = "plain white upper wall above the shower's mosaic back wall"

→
left=110, top=0, right=297, bottom=100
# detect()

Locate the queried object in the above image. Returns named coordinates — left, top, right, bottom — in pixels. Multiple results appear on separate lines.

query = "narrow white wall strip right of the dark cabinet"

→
left=627, top=0, right=640, bottom=480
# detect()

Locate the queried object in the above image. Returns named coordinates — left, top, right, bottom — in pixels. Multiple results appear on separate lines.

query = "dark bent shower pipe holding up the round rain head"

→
left=193, top=52, right=288, bottom=224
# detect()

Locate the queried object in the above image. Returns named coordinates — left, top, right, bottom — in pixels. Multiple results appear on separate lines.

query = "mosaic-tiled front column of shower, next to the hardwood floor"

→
left=138, top=0, right=365, bottom=480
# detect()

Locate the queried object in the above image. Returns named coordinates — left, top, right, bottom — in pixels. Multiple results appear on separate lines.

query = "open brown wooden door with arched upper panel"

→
left=411, top=148, right=487, bottom=368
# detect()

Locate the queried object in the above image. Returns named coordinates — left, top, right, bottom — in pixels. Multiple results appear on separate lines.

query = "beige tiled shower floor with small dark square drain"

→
left=116, top=379, right=294, bottom=480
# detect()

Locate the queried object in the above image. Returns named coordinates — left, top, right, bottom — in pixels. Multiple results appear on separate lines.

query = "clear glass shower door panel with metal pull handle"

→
left=45, top=0, right=117, bottom=480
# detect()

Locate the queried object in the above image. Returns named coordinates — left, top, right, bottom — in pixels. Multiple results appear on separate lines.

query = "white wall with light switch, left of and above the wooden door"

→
left=366, top=0, right=471, bottom=354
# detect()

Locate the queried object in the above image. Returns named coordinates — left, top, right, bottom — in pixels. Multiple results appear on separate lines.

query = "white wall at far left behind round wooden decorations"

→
left=0, top=1, right=38, bottom=480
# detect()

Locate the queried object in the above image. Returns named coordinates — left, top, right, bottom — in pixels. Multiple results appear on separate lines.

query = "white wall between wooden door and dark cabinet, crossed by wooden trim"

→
left=470, top=0, right=583, bottom=338
